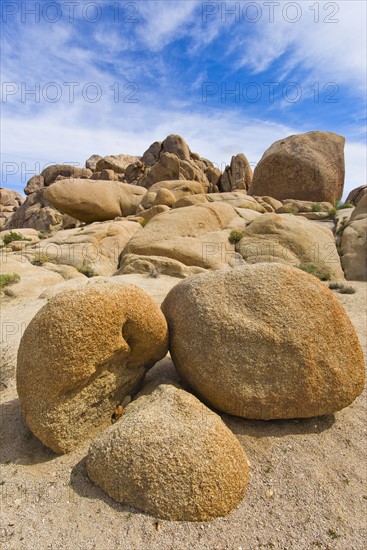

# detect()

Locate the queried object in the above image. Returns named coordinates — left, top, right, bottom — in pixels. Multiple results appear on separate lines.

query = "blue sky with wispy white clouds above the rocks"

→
left=1, top=0, right=367, bottom=197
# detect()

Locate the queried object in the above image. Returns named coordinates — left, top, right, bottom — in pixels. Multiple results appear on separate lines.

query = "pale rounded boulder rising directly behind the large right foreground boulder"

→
left=236, top=213, right=344, bottom=280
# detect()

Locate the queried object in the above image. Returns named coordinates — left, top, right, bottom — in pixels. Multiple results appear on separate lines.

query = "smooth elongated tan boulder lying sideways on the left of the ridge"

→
left=44, top=179, right=146, bottom=223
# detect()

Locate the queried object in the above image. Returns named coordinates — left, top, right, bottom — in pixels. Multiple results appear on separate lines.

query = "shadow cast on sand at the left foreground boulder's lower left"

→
left=0, top=399, right=58, bottom=466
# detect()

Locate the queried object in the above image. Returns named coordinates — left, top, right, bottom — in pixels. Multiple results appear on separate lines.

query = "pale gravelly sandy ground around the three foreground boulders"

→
left=0, top=279, right=367, bottom=550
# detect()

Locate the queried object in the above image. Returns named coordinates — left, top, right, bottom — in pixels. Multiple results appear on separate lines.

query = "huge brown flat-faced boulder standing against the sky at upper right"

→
left=249, top=132, right=345, bottom=204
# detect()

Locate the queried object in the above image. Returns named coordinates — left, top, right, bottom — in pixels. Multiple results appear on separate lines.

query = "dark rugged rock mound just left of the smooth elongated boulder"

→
left=4, top=189, right=63, bottom=233
